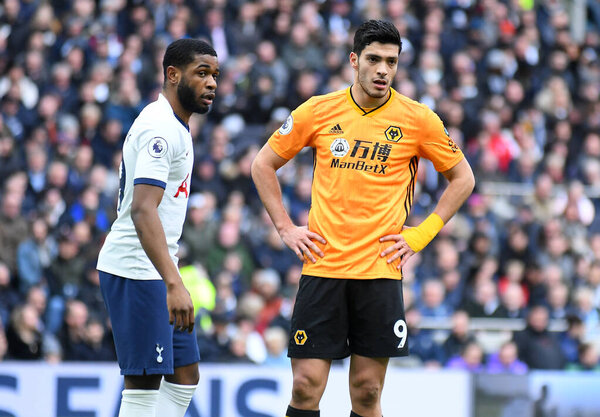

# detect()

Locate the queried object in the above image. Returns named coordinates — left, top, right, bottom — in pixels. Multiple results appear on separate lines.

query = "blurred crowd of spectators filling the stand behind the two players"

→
left=0, top=0, right=600, bottom=373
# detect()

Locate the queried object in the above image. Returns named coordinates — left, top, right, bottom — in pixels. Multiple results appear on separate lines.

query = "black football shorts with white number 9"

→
left=288, top=275, right=408, bottom=359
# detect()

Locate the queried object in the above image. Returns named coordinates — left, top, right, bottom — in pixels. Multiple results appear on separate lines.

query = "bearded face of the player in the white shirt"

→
left=177, top=55, right=219, bottom=113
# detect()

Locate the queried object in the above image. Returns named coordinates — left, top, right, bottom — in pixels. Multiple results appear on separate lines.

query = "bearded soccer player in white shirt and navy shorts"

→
left=97, top=39, right=219, bottom=417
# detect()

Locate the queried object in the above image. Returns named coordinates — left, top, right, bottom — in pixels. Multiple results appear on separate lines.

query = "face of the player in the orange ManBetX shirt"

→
left=350, top=42, right=400, bottom=100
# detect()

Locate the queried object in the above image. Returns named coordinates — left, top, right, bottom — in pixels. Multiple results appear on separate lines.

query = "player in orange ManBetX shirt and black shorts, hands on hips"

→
left=252, top=20, right=475, bottom=417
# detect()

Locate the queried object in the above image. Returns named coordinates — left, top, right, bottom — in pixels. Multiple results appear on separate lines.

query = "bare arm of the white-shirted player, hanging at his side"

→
left=131, top=184, right=194, bottom=332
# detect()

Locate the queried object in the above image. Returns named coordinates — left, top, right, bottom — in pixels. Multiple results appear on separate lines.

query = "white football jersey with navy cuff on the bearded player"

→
left=98, top=94, right=194, bottom=280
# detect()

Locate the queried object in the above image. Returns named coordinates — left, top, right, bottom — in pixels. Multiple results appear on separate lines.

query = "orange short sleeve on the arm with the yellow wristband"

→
left=419, top=108, right=464, bottom=172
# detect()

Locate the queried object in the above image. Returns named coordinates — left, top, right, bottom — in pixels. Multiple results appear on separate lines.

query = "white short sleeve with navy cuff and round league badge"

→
left=133, top=132, right=175, bottom=188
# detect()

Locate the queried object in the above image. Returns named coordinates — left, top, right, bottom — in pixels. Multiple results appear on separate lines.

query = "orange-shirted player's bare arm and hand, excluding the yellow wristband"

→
left=379, top=159, right=475, bottom=269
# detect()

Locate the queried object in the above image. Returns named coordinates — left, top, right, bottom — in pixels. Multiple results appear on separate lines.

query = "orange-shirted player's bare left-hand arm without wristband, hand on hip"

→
left=252, top=144, right=326, bottom=263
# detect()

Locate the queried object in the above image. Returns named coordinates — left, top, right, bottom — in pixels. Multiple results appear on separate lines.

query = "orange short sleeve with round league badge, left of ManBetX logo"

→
left=268, top=99, right=314, bottom=159
